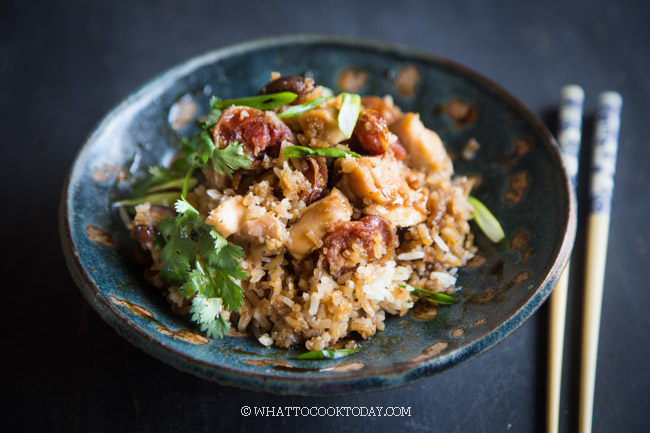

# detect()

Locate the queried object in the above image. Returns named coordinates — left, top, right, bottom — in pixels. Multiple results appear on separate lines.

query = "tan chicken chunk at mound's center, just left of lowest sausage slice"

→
left=287, top=188, right=352, bottom=259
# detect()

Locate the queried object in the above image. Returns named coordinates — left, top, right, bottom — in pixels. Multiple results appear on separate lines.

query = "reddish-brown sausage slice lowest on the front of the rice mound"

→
left=320, top=216, right=395, bottom=277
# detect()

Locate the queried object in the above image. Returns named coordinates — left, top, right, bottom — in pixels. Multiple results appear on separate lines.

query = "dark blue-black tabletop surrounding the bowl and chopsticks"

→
left=5, top=0, right=650, bottom=432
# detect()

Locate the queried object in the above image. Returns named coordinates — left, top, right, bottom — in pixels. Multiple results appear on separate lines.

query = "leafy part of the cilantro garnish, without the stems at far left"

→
left=157, top=136, right=250, bottom=338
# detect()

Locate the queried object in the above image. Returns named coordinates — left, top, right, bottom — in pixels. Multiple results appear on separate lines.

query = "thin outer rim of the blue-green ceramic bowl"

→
left=59, top=34, right=577, bottom=395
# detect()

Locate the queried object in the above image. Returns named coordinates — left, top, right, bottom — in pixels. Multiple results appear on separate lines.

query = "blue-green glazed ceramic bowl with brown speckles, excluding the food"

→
left=60, top=36, right=576, bottom=395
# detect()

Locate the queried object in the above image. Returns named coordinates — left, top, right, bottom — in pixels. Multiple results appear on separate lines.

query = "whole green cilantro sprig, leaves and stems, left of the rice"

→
left=123, top=98, right=251, bottom=338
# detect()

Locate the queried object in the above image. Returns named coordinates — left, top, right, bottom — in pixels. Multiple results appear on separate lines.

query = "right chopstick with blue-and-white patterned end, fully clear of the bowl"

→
left=578, top=91, right=623, bottom=433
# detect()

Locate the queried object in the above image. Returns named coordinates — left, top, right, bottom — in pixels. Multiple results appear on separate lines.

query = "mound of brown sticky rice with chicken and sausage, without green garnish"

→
left=126, top=75, right=476, bottom=350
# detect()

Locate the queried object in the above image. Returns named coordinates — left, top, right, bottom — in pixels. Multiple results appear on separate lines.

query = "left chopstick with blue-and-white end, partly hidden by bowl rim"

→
left=546, top=85, right=585, bottom=433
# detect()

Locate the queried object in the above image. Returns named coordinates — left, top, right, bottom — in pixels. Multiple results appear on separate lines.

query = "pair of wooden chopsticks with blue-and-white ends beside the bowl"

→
left=546, top=85, right=623, bottom=433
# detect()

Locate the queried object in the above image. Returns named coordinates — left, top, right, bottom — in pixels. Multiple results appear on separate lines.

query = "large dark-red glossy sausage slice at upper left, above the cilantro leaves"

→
left=212, top=106, right=296, bottom=170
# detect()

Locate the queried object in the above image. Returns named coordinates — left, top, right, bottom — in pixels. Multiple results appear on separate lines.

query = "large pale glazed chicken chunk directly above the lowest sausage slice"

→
left=336, top=152, right=427, bottom=227
